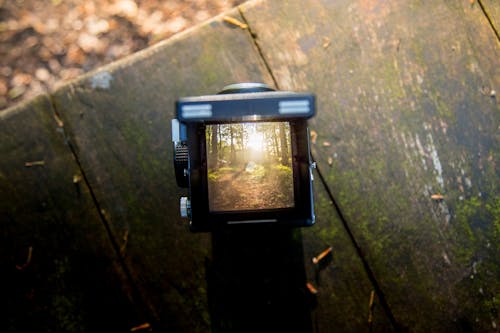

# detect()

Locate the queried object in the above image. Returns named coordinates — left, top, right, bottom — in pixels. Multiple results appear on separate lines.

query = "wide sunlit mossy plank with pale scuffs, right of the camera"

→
left=242, top=0, right=500, bottom=332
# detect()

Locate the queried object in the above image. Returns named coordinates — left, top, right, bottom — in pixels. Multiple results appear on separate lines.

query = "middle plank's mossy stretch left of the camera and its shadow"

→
left=53, top=11, right=288, bottom=332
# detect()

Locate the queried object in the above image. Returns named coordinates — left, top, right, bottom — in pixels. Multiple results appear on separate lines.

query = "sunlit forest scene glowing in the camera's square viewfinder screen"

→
left=206, top=122, right=294, bottom=211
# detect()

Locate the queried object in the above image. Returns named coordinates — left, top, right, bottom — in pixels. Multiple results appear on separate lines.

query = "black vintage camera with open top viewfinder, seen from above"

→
left=172, top=83, right=315, bottom=231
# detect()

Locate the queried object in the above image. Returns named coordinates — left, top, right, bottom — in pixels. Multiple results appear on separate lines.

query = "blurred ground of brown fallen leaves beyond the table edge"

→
left=0, top=0, right=245, bottom=110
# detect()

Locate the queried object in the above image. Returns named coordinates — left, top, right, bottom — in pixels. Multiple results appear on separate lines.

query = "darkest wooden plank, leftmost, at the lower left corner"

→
left=0, top=96, right=144, bottom=332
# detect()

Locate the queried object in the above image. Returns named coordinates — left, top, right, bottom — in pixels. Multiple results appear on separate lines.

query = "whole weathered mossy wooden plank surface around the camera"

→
left=0, top=0, right=500, bottom=332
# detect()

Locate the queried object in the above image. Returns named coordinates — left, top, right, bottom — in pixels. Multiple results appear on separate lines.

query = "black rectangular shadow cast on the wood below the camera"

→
left=206, top=225, right=313, bottom=332
